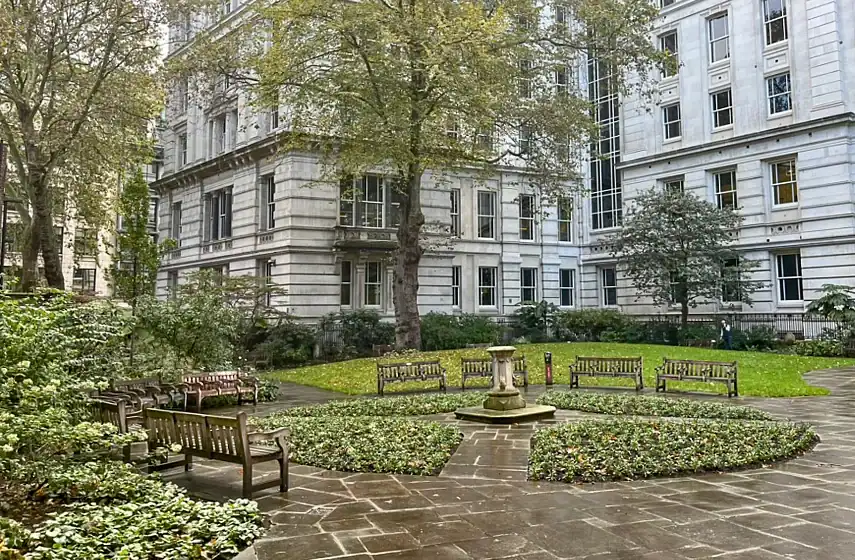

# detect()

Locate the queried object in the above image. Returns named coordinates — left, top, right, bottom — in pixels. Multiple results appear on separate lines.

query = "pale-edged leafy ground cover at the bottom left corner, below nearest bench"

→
left=27, top=490, right=262, bottom=560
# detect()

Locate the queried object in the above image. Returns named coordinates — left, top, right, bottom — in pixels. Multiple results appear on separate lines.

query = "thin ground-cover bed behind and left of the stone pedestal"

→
left=280, top=391, right=484, bottom=417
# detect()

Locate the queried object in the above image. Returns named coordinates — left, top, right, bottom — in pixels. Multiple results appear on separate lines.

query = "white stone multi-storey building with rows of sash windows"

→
left=156, top=0, right=855, bottom=319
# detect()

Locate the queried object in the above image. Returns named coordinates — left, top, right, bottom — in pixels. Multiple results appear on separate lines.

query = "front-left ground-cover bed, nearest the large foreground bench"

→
left=252, top=414, right=463, bottom=476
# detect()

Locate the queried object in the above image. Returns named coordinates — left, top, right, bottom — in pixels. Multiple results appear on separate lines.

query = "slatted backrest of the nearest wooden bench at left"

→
left=145, top=410, right=249, bottom=459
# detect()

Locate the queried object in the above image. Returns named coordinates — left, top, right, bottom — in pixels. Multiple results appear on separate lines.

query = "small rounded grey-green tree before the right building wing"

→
left=607, top=189, right=761, bottom=326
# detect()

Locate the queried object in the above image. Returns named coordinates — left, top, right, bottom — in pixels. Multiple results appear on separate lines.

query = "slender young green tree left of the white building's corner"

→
left=110, top=169, right=174, bottom=306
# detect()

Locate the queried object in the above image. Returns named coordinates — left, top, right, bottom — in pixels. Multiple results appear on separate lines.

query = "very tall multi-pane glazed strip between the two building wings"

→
left=588, top=57, right=623, bottom=230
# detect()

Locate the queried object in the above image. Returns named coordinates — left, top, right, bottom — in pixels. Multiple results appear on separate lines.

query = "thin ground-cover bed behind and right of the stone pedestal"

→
left=537, top=391, right=773, bottom=420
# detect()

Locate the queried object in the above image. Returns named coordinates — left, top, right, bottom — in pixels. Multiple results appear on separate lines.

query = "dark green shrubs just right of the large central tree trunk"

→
left=421, top=312, right=499, bottom=350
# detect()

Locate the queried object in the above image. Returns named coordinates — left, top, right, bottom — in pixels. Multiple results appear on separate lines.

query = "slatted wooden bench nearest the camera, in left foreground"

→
left=144, top=408, right=290, bottom=499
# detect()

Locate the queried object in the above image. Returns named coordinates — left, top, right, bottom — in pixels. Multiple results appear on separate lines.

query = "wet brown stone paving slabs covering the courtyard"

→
left=168, top=369, right=855, bottom=560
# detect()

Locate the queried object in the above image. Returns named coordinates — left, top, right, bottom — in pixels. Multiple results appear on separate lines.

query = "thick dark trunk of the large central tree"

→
left=392, top=169, right=425, bottom=350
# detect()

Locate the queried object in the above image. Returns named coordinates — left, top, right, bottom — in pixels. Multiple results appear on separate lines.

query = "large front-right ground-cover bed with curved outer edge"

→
left=529, top=419, right=818, bottom=482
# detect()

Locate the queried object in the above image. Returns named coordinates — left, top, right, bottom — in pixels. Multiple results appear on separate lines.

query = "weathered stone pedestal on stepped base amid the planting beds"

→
left=454, top=346, right=555, bottom=424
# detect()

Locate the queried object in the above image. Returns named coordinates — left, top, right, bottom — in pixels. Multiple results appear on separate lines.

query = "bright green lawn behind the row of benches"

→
left=266, top=342, right=855, bottom=397
